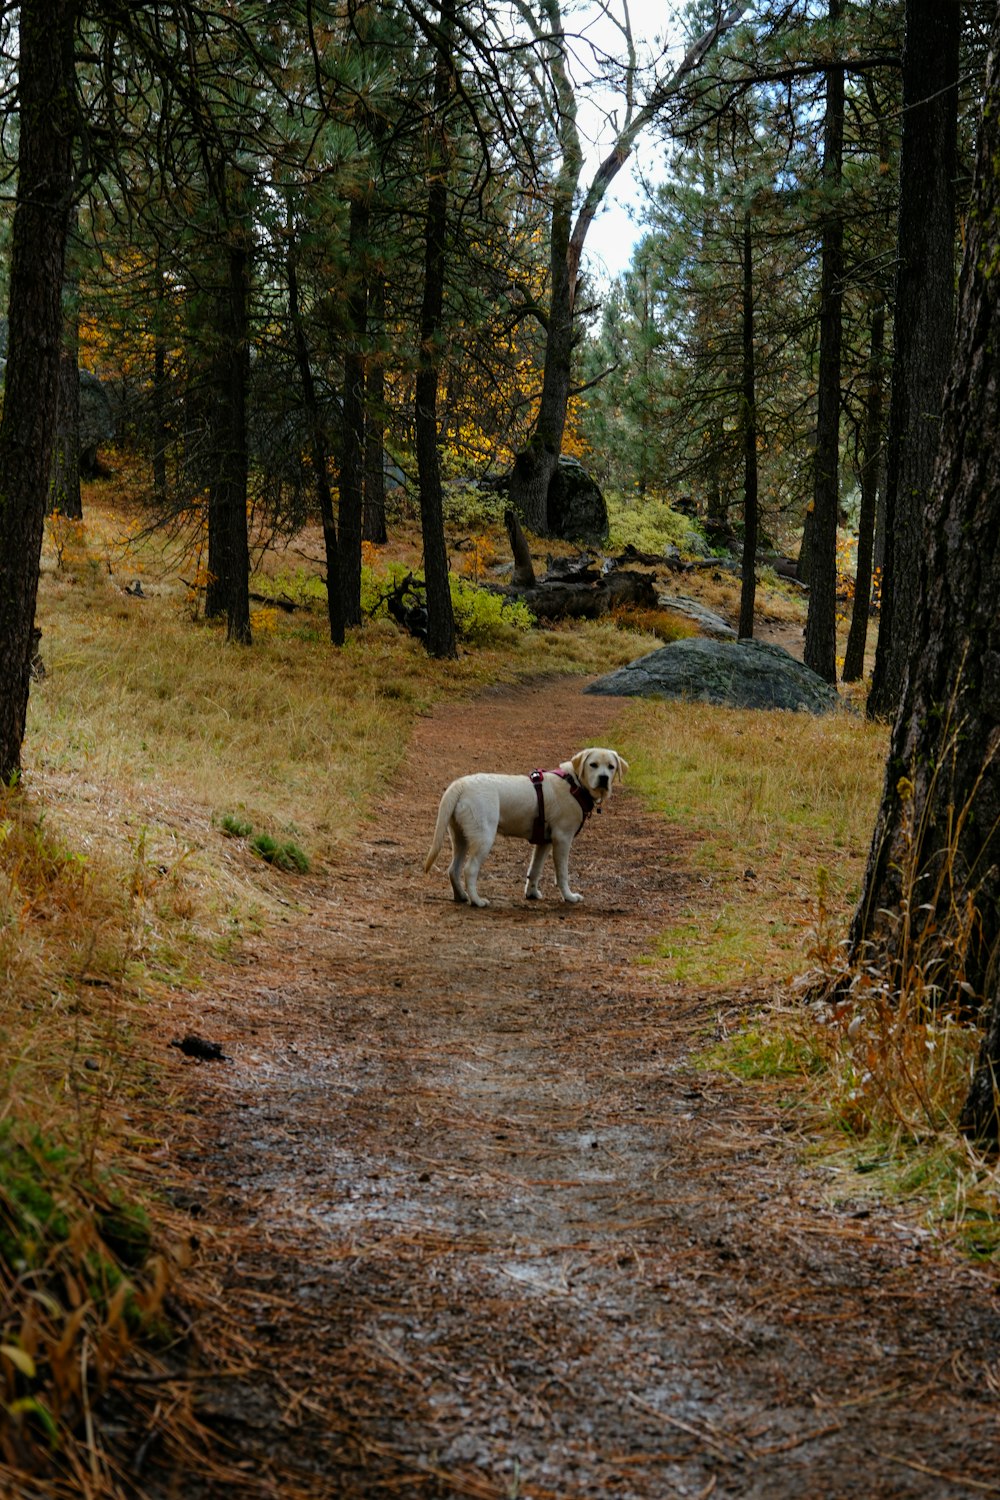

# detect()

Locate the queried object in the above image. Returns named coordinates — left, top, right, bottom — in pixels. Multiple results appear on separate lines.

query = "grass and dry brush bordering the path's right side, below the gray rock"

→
left=625, top=704, right=1000, bottom=1259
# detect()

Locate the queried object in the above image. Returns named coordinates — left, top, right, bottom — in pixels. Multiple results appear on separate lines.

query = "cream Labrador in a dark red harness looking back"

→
left=424, top=747, right=628, bottom=906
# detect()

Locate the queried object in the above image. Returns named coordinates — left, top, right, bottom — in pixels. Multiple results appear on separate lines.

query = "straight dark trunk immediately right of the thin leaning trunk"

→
left=337, top=185, right=370, bottom=626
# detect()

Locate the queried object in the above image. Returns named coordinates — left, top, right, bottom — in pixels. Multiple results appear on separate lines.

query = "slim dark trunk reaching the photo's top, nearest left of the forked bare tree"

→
left=415, top=0, right=457, bottom=657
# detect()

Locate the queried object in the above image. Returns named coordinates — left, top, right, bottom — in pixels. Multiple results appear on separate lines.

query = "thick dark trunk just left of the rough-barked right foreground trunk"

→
left=868, top=0, right=961, bottom=717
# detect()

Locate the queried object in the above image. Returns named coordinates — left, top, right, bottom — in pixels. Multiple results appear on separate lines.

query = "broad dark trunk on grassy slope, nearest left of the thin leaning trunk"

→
left=205, top=227, right=252, bottom=645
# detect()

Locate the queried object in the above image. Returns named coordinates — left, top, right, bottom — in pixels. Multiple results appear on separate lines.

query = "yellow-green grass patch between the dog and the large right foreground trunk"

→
left=624, top=702, right=886, bottom=992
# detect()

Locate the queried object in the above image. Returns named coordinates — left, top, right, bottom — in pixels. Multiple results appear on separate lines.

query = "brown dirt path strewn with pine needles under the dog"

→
left=158, top=684, right=1000, bottom=1500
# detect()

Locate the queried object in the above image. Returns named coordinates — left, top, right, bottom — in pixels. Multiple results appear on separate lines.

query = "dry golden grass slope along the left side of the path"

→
left=0, top=489, right=665, bottom=1497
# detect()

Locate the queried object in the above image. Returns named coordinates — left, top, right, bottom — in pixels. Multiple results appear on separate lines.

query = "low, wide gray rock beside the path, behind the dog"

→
left=586, top=636, right=844, bottom=714
